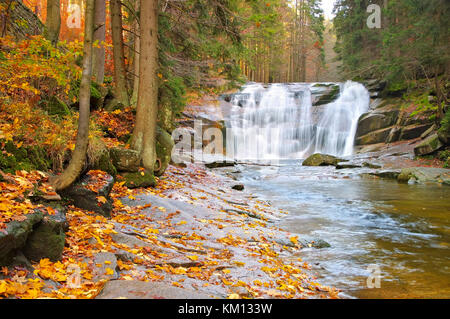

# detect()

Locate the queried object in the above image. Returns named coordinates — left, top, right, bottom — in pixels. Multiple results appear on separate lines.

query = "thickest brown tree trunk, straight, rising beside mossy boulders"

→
left=132, top=0, right=158, bottom=174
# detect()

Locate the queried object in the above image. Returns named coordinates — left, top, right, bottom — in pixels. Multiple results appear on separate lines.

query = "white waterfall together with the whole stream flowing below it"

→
left=225, top=82, right=450, bottom=298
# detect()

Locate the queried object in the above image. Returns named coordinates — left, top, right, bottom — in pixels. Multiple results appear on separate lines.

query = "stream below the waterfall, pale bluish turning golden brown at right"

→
left=240, top=162, right=450, bottom=298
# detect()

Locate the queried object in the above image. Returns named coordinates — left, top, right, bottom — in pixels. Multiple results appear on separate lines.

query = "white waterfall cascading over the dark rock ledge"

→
left=230, top=81, right=370, bottom=161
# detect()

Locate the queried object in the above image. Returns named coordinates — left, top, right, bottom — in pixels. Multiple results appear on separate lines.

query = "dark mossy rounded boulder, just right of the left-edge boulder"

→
left=22, top=206, right=68, bottom=262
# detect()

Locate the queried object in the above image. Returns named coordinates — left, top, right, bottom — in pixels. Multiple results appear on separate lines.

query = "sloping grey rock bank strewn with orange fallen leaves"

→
left=0, top=164, right=337, bottom=299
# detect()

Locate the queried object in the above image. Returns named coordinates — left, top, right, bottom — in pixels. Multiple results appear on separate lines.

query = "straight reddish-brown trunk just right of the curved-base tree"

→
left=92, top=0, right=106, bottom=83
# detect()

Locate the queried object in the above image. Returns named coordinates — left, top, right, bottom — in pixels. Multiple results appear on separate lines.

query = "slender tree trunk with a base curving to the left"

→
left=50, top=0, right=94, bottom=191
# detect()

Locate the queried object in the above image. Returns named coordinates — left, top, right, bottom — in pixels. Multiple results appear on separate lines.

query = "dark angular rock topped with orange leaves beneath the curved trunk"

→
left=61, top=171, right=114, bottom=217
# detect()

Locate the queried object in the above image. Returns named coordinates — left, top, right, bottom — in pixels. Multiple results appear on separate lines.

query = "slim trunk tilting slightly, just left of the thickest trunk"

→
left=110, top=0, right=130, bottom=106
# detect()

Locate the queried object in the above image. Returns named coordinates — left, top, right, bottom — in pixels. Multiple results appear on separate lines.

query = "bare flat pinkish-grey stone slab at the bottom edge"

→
left=96, top=280, right=215, bottom=299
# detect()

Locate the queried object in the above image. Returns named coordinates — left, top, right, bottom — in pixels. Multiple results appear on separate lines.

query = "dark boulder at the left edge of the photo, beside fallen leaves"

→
left=0, top=212, right=43, bottom=266
